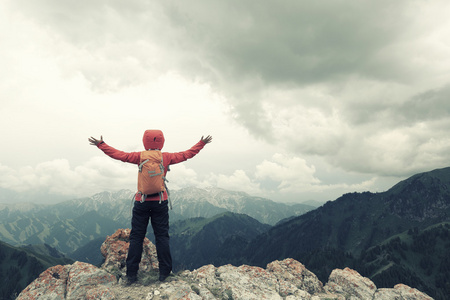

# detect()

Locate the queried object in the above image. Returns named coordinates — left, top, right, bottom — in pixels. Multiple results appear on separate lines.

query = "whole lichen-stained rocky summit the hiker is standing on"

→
left=17, top=229, right=432, bottom=300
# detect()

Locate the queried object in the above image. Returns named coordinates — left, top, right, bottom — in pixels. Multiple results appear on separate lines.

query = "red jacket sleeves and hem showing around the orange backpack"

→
left=97, top=141, right=206, bottom=201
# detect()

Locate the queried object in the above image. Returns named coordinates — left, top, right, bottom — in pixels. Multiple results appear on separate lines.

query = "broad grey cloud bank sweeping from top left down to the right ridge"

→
left=11, top=0, right=450, bottom=175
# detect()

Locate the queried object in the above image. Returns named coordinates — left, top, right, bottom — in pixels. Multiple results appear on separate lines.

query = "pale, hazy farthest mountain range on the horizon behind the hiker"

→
left=0, top=188, right=314, bottom=254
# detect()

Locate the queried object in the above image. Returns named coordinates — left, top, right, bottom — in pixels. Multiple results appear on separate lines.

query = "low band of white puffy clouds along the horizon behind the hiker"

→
left=0, top=154, right=400, bottom=202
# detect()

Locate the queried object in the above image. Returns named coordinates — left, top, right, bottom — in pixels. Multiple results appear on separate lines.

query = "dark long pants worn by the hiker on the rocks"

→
left=127, top=201, right=172, bottom=276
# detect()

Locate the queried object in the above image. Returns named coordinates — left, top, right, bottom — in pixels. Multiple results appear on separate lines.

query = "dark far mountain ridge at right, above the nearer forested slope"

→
left=243, top=168, right=450, bottom=263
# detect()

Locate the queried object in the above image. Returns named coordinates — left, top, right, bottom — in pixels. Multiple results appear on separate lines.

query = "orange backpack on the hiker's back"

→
left=138, top=150, right=166, bottom=202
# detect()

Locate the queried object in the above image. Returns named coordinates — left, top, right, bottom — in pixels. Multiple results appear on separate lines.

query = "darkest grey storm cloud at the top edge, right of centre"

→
left=158, top=1, right=409, bottom=84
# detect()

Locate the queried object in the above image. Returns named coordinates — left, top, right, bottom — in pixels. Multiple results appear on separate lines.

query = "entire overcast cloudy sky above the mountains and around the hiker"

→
left=0, top=0, right=450, bottom=202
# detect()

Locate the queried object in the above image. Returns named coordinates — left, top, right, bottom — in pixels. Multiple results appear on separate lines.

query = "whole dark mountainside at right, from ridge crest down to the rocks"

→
left=236, top=168, right=450, bottom=299
